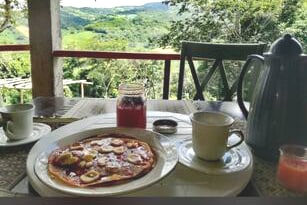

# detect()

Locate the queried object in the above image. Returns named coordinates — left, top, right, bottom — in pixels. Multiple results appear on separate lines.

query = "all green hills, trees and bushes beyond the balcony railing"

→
left=0, top=0, right=307, bottom=102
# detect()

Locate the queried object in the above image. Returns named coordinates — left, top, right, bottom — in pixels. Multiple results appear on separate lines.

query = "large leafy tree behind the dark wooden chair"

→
left=157, top=0, right=307, bottom=98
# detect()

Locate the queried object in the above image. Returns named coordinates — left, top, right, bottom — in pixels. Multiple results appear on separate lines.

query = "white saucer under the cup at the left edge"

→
left=0, top=122, right=51, bottom=147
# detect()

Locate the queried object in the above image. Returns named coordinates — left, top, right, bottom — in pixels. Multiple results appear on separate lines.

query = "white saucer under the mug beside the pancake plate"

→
left=178, top=139, right=252, bottom=175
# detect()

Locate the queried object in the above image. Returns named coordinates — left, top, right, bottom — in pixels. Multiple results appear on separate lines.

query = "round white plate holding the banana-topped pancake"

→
left=34, top=128, right=178, bottom=196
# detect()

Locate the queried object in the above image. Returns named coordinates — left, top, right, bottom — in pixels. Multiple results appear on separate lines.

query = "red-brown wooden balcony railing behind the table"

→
left=0, top=45, right=180, bottom=99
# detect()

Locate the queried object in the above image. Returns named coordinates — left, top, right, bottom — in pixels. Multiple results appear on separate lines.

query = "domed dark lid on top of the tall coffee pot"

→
left=270, top=34, right=303, bottom=56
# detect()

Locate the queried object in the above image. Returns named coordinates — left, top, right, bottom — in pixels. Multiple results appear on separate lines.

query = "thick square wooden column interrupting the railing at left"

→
left=28, top=0, right=63, bottom=98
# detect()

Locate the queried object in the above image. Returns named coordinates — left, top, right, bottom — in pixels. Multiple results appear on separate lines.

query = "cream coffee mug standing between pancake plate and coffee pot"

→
left=190, top=112, right=244, bottom=160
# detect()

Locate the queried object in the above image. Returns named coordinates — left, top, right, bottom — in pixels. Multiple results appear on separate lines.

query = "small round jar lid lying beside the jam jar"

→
left=153, top=119, right=178, bottom=134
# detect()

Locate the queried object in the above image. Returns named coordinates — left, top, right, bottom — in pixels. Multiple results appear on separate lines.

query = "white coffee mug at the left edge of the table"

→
left=0, top=104, right=34, bottom=140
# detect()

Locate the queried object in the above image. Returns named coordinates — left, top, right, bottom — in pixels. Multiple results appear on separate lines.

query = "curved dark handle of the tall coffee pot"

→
left=237, top=54, right=264, bottom=119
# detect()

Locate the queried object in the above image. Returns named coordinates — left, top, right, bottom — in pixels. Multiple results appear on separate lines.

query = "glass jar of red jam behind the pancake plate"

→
left=116, top=84, right=146, bottom=129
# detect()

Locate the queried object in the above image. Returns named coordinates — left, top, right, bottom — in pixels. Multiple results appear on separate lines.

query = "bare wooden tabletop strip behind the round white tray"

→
left=33, top=97, right=245, bottom=120
